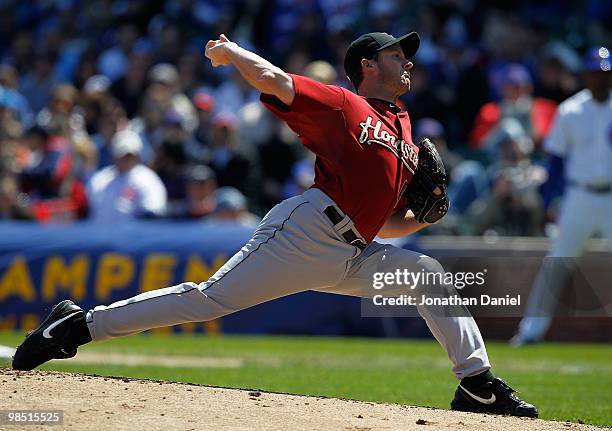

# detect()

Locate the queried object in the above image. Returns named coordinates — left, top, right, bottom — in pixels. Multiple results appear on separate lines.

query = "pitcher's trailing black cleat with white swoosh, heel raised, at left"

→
left=13, top=300, right=85, bottom=371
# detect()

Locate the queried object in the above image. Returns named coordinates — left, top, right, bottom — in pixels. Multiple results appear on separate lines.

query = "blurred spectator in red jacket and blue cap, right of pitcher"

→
left=470, top=63, right=557, bottom=153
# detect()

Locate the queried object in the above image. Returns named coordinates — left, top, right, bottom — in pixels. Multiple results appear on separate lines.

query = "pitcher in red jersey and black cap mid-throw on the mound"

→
left=13, top=32, right=538, bottom=417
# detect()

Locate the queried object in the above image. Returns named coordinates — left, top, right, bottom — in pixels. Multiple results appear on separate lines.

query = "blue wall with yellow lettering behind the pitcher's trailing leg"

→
left=0, top=221, right=427, bottom=336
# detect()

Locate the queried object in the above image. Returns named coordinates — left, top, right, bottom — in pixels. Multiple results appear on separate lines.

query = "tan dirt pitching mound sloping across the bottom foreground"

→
left=0, top=369, right=598, bottom=431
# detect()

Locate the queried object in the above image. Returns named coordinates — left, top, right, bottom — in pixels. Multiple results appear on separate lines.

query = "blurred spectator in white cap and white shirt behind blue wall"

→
left=88, top=130, right=166, bottom=224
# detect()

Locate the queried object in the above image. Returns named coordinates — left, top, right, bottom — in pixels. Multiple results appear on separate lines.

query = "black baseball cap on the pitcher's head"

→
left=344, top=31, right=421, bottom=81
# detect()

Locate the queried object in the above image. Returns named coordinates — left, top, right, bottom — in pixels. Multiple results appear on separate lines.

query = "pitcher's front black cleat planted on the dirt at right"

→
left=451, top=378, right=538, bottom=418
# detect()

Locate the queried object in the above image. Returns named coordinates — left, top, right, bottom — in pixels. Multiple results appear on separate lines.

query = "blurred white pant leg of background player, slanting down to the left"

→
left=519, top=188, right=599, bottom=340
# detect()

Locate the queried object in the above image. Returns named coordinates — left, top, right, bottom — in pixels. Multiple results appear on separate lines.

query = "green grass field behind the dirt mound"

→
left=0, top=333, right=612, bottom=426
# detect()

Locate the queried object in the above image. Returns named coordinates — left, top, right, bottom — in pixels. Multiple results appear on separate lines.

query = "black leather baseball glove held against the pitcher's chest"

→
left=406, top=138, right=449, bottom=223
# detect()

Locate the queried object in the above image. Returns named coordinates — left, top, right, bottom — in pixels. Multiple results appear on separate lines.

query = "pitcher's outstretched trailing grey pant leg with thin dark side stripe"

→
left=87, top=197, right=355, bottom=340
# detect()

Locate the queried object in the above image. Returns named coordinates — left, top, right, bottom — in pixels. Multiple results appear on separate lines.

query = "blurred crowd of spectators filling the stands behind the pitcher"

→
left=0, top=0, right=612, bottom=235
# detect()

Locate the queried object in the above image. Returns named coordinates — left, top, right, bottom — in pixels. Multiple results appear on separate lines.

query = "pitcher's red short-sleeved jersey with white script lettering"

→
left=261, top=75, right=418, bottom=241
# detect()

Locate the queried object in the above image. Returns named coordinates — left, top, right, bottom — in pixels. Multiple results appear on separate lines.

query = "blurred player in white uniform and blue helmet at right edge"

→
left=511, top=46, right=612, bottom=346
